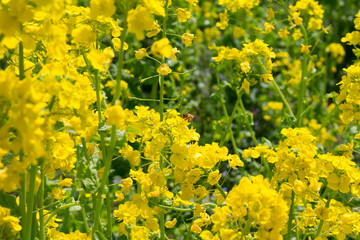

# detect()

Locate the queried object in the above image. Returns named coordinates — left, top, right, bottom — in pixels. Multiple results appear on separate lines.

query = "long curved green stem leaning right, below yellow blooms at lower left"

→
left=93, top=125, right=116, bottom=232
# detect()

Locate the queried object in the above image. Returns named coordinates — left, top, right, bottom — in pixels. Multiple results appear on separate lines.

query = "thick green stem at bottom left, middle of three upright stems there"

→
left=24, top=165, right=37, bottom=240
